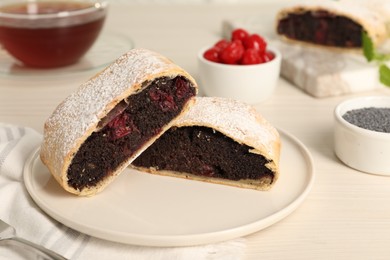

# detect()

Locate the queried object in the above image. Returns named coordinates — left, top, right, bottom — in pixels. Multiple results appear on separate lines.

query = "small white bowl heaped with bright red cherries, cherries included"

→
left=198, top=28, right=281, bottom=104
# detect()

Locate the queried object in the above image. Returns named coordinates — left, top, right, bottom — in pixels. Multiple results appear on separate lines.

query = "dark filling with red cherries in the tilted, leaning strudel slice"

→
left=67, top=76, right=195, bottom=190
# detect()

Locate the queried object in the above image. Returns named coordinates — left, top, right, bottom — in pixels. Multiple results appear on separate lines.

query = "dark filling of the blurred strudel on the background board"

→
left=277, top=10, right=362, bottom=48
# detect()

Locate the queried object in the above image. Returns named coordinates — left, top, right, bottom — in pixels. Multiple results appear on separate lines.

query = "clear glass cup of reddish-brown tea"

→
left=0, top=0, right=108, bottom=68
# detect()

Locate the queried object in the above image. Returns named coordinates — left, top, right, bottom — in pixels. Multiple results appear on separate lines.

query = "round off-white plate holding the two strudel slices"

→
left=24, top=131, right=313, bottom=246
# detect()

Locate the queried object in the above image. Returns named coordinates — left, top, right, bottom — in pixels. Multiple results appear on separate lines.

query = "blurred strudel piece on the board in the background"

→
left=276, top=0, right=388, bottom=50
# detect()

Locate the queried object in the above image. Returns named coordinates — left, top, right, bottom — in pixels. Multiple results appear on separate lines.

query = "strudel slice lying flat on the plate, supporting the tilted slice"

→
left=132, top=97, right=280, bottom=190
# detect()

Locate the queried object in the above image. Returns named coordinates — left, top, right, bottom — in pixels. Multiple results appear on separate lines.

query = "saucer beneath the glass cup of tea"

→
left=0, top=31, right=134, bottom=79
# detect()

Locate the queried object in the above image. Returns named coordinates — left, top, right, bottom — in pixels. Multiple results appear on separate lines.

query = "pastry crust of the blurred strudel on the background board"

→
left=276, top=0, right=388, bottom=50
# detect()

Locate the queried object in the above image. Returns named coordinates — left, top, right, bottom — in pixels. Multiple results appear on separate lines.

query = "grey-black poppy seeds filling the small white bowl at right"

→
left=343, top=107, right=390, bottom=133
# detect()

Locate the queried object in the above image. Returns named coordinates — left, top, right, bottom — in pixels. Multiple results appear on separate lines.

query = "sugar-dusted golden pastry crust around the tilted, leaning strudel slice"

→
left=40, top=49, right=197, bottom=196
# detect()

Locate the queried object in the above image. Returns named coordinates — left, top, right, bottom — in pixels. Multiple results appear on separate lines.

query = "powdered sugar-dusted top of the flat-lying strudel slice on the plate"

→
left=174, top=97, right=280, bottom=157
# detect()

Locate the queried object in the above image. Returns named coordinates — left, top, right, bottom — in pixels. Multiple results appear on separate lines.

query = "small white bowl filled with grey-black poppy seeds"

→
left=334, top=96, right=390, bottom=176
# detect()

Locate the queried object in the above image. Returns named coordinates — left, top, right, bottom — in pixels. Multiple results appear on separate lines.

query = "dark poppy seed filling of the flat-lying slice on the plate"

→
left=132, top=126, right=274, bottom=180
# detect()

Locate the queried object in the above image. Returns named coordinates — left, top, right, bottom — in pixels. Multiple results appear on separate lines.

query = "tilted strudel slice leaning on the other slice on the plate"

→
left=40, top=49, right=197, bottom=195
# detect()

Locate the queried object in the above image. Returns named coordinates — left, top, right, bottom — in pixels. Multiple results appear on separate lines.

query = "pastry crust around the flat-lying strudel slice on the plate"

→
left=135, top=97, right=281, bottom=190
